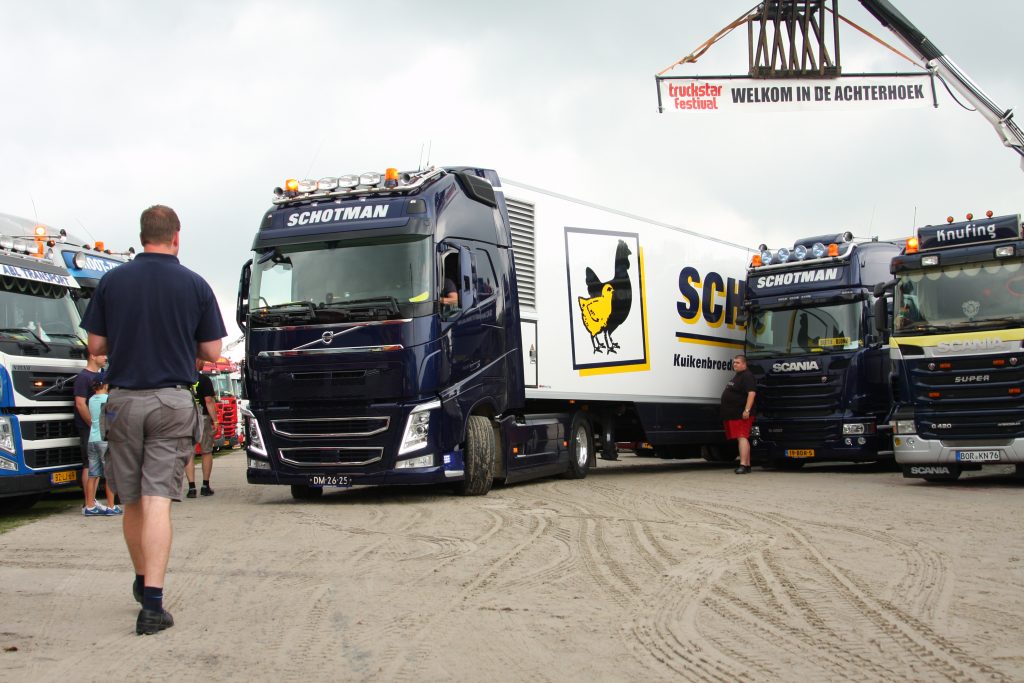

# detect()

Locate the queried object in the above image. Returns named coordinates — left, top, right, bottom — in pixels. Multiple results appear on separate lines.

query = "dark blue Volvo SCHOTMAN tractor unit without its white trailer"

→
left=238, top=168, right=594, bottom=499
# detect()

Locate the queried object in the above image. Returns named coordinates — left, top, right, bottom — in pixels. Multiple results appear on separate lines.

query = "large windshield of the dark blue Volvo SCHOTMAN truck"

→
left=249, top=236, right=433, bottom=327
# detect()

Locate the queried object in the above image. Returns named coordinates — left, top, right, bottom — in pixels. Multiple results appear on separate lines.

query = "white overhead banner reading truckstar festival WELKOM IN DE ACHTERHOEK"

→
left=656, top=74, right=935, bottom=114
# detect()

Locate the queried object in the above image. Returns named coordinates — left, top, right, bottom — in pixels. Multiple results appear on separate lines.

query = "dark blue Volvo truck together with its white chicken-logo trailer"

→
left=239, top=168, right=749, bottom=499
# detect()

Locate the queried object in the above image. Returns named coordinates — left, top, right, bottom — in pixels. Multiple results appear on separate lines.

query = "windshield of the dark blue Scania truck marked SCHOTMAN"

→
left=746, top=302, right=863, bottom=358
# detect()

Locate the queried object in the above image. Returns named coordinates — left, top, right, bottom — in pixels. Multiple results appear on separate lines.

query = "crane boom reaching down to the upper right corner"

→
left=860, top=0, right=1024, bottom=169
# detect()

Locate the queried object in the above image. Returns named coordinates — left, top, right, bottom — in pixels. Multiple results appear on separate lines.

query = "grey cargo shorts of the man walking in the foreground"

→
left=104, top=388, right=201, bottom=503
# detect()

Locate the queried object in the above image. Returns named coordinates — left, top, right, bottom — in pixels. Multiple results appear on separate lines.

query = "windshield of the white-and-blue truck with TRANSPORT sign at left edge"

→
left=0, top=275, right=84, bottom=355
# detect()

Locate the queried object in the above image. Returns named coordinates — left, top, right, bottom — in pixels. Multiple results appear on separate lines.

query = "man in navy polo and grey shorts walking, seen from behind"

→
left=82, top=206, right=226, bottom=635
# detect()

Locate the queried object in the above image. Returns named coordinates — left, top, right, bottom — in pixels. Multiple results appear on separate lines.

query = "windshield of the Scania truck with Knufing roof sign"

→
left=894, top=258, right=1024, bottom=335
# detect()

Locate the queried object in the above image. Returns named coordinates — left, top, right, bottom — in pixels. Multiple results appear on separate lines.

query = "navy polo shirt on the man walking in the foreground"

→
left=82, top=252, right=227, bottom=389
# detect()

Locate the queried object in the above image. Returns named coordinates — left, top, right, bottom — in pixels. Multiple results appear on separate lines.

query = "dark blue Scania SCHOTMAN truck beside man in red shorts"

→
left=746, top=232, right=900, bottom=468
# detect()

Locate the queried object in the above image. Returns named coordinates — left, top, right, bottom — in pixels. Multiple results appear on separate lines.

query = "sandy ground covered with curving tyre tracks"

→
left=0, top=453, right=1024, bottom=682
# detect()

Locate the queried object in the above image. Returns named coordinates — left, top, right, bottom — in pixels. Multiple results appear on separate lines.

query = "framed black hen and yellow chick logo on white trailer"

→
left=565, top=232, right=650, bottom=375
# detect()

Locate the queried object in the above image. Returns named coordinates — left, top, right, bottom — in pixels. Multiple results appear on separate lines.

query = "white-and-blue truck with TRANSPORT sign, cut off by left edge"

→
left=0, top=214, right=86, bottom=511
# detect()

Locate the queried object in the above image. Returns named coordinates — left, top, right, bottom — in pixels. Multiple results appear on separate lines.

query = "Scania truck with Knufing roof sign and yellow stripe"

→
left=879, top=211, right=1024, bottom=481
